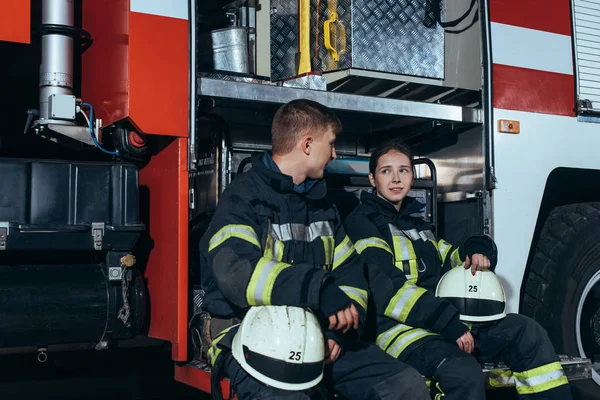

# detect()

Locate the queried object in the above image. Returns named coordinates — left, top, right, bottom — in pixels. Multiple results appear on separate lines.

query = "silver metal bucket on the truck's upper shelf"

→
left=198, top=27, right=250, bottom=74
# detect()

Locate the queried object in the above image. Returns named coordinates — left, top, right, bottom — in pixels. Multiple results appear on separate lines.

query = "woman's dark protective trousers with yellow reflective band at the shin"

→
left=405, top=314, right=572, bottom=400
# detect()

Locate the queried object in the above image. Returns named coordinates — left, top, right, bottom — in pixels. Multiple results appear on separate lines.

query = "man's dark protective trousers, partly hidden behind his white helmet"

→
left=221, top=341, right=430, bottom=400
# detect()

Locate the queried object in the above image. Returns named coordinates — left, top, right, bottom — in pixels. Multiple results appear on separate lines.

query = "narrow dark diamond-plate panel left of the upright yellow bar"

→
left=271, top=0, right=299, bottom=81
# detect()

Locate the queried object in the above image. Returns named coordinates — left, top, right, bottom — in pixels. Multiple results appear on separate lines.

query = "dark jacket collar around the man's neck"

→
left=252, top=152, right=327, bottom=200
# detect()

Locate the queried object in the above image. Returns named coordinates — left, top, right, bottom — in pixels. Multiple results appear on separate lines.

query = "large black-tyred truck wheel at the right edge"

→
left=522, top=203, right=600, bottom=399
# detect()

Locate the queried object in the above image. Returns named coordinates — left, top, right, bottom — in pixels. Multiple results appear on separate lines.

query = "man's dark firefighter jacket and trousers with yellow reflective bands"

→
left=200, top=153, right=428, bottom=399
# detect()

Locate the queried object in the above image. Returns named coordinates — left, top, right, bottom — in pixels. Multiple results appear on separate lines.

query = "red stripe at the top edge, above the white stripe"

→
left=490, top=0, right=571, bottom=36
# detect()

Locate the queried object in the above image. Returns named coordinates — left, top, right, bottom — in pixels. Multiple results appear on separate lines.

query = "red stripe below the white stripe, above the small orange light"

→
left=493, top=64, right=575, bottom=116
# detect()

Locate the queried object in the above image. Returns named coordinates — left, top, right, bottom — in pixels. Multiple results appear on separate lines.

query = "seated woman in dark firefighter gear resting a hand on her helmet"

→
left=344, top=139, right=571, bottom=400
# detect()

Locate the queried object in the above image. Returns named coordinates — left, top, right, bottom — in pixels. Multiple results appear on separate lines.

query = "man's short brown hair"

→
left=271, top=99, right=342, bottom=154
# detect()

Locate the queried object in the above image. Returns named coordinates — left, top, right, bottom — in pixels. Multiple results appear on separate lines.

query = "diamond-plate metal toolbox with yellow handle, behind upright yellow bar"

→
left=270, top=0, right=444, bottom=81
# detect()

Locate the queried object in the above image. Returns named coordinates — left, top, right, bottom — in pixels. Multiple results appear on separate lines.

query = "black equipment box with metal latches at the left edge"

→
left=0, top=158, right=145, bottom=251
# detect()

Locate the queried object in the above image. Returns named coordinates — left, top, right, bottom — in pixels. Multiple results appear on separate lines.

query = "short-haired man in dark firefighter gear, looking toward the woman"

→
left=200, top=99, right=429, bottom=400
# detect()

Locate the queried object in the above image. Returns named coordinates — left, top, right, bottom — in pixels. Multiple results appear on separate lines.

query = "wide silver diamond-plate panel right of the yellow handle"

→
left=352, top=0, right=444, bottom=79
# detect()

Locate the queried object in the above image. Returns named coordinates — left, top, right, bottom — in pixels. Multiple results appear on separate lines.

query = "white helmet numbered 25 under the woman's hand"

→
left=435, top=265, right=506, bottom=323
